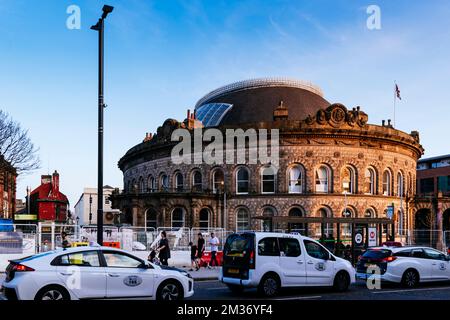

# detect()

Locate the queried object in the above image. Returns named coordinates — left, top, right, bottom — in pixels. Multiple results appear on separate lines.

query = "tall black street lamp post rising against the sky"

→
left=91, top=5, right=114, bottom=245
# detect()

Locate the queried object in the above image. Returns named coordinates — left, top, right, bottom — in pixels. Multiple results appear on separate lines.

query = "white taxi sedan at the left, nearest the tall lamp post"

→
left=2, top=246, right=194, bottom=300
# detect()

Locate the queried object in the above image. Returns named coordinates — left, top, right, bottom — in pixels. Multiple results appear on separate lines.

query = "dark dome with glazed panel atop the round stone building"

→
left=195, top=78, right=330, bottom=126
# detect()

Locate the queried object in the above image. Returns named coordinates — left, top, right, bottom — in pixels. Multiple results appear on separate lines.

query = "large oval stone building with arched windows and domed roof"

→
left=112, top=79, right=423, bottom=241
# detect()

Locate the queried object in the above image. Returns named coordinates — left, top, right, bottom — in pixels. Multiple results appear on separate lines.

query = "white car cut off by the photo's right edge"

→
left=356, top=247, right=450, bottom=288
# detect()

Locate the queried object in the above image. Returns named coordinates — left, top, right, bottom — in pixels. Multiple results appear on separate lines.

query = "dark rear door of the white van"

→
left=222, top=233, right=255, bottom=279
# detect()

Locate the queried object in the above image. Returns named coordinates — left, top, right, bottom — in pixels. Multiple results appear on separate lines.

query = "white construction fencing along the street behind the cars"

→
left=0, top=223, right=450, bottom=255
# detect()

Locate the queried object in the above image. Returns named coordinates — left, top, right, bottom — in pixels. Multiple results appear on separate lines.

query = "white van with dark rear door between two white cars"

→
left=220, top=232, right=356, bottom=297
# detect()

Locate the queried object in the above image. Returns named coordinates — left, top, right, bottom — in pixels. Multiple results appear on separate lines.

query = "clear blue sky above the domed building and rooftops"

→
left=0, top=0, right=450, bottom=206
